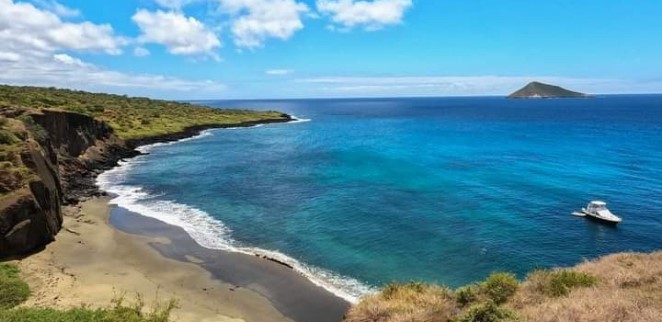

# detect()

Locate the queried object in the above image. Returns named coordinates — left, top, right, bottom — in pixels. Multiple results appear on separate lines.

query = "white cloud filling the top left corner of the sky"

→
left=0, top=0, right=128, bottom=55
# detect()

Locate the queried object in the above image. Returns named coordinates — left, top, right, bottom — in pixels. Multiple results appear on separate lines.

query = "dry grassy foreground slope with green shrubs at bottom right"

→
left=345, top=252, right=662, bottom=322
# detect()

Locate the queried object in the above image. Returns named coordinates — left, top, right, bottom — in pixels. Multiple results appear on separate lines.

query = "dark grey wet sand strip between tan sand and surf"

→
left=110, top=207, right=349, bottom=322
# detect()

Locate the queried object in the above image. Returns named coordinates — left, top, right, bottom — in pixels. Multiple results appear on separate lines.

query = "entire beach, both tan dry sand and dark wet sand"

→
left=16, top=198, right=349, bottom=322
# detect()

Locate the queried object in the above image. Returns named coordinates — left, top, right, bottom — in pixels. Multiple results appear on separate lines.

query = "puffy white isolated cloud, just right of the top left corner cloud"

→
left=132, top=9, right=221, bottom=58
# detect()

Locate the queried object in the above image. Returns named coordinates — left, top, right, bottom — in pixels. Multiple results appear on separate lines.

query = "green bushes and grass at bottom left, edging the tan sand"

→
left=0, top=264, right=176, bottom=322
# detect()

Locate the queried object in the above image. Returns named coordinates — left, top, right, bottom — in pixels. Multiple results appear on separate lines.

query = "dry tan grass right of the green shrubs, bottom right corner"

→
left=513, top=252, right=662, bottom=322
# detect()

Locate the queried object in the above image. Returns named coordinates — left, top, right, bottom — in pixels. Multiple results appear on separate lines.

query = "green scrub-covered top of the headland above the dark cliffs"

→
left=0, top=85, right=289, bottom=199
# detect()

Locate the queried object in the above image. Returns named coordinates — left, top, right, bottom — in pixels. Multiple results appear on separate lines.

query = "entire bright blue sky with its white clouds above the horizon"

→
left=0, top=0, right=662, bottom=99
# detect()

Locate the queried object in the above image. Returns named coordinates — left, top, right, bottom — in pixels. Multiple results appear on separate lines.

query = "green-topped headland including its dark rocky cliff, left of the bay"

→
left=0, top=85, right=292, bottom=258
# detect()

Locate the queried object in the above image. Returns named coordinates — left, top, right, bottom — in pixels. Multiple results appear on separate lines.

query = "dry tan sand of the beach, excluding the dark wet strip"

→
left=10, top=199, right=300, bottom=321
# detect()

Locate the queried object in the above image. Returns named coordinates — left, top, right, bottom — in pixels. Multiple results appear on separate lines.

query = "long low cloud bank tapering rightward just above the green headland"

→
left=0, top=54, right=226, bottom=99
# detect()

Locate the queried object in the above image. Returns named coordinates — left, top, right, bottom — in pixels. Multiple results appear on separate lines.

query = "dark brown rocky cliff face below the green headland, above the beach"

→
left=0, top=111, right=137, bottom=258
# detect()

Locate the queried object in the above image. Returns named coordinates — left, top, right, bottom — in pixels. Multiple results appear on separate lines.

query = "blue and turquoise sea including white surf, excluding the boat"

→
left=96, top=95, right=662, bottom=302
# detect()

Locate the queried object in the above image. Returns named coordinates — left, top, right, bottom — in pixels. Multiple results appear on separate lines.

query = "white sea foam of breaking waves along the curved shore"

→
left=97, top=117, right=375, bottom=303
